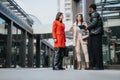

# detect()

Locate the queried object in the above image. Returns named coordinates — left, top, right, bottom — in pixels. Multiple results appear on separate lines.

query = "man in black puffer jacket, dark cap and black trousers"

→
left=87, top=4, right=104, bottom=70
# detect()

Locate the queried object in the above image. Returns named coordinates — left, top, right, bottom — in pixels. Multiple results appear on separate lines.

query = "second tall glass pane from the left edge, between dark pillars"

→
left=11, top=25, right=21, bottom=67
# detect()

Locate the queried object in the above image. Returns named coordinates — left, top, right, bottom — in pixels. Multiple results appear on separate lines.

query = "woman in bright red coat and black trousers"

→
left=52, top=12, right=66, bottom=70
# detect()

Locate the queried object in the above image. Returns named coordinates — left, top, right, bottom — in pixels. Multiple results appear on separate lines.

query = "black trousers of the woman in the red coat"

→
left=53, top=48, right=65, bottom=68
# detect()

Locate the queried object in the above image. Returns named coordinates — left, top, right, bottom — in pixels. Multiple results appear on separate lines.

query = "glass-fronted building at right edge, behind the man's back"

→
left=95, top=0, right=120, bottom=65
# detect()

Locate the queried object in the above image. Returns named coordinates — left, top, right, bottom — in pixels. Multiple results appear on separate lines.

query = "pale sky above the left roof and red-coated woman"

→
left=14, top=0, right=64, bottom=24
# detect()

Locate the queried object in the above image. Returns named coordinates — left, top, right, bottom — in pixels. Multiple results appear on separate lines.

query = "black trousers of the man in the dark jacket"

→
left=88, top=35, right=103, bottom=68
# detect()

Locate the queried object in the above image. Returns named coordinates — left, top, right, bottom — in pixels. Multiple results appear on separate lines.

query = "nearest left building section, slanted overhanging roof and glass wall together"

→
left=0, top=0, right=33, bottom=67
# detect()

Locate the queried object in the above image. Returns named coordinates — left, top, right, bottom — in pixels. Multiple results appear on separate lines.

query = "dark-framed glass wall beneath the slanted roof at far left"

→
left=0, top=17, right=33, bottom=67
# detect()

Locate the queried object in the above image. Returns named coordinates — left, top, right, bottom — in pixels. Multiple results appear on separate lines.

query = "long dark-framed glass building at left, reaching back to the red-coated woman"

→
left=0, top=0, right=53, bottom=68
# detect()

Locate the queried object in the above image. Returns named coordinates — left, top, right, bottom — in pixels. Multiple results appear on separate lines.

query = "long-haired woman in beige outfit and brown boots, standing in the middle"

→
left=69, top=14, right=89, bottom=70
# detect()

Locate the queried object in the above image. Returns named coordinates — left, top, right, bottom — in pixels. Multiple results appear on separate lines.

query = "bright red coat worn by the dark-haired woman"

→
left=52, top=20, right=66, bottom=48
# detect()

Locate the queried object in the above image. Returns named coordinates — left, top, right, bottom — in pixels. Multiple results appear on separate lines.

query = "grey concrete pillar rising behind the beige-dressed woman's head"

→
left=72, top=0, right=94, bottom=22
